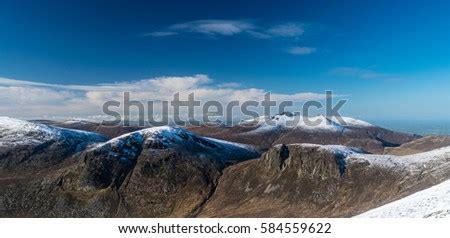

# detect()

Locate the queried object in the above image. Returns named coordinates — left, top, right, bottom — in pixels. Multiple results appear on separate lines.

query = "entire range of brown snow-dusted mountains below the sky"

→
left=0, top=113, right=450, bottom=217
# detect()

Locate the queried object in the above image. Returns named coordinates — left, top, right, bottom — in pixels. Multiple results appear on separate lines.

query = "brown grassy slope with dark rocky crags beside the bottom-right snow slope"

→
left=200, top=144, right=450, bottom=217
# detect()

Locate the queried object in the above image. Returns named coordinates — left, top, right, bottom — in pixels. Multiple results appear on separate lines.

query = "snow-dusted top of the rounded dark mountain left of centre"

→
left=80, top=126, right=260, bottom=192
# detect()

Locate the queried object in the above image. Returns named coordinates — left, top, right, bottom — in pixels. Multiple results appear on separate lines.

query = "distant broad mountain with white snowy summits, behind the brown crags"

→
left=189, top=113, right=420, bottom=154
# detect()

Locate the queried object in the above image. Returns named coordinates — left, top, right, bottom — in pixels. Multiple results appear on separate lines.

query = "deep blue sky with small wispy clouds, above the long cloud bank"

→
left=0, top=0, right=450, bottom=119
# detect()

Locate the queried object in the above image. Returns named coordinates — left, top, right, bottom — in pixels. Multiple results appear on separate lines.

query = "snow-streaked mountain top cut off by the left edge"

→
left=0, top=117, right=106, bottom=169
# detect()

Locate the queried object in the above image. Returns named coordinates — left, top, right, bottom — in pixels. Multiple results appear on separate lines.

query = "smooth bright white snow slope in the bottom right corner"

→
left=356, top=180, right=450, bottom=218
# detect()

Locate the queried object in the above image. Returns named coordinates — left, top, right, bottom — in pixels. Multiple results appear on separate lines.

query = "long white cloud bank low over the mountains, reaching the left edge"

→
left=0, top=74, right=325, bottom=118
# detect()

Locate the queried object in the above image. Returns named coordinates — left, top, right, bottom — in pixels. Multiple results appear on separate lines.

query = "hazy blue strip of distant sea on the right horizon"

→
left=368, top=120, right=450, bottom=135
